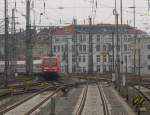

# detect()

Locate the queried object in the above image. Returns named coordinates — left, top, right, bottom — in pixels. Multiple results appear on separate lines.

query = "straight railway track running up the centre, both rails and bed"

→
left=74, top=79, right=110, bottom=115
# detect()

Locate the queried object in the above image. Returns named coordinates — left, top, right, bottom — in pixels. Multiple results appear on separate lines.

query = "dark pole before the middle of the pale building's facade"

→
left=88, top=17, right=93, bottom=73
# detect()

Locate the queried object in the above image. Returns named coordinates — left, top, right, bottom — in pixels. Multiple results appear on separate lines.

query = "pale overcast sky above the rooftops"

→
left=0, top=0, right=150, bottom=30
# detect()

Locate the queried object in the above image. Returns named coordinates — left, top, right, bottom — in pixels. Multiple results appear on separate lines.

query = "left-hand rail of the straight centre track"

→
left=75, top=83, right=88, bottom=115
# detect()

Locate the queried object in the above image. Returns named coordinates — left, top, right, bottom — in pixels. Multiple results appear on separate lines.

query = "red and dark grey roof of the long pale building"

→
left=54, top=24, right=146, bottom=35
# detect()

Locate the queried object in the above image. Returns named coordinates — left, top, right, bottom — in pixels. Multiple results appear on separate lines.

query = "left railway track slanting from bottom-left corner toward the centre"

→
left=0, top=79, right=85, bottom=115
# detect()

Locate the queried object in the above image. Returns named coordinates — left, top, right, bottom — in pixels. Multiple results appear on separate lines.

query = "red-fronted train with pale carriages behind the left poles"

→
left=0, top=56, right=61, bottom=80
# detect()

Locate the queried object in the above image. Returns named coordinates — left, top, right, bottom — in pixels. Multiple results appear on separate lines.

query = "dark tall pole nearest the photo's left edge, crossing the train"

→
left=4, top=0, right=9, bottom=87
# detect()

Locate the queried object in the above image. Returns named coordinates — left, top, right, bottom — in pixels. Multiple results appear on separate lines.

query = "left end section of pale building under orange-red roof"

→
left=52, top=27, right=74, bottom=72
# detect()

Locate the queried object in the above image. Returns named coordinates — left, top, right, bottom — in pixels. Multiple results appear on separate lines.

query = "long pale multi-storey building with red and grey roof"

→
left=52, top=24, right=150, bottom=73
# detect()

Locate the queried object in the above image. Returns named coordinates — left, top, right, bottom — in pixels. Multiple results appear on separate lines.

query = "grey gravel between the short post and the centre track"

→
left=56, top=87, right=82, bottom=115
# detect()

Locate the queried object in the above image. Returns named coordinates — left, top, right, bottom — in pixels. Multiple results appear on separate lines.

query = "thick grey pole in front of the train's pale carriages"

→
left=26, top=0, right=33, bottom=75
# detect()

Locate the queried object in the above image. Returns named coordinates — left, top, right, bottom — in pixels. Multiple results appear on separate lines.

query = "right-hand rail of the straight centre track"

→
left=97, top=82, right=110, bottom=115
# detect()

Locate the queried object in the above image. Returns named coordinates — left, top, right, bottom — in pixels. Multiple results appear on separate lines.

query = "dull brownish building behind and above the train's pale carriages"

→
left=0, top=29, right=51, bottom=60
